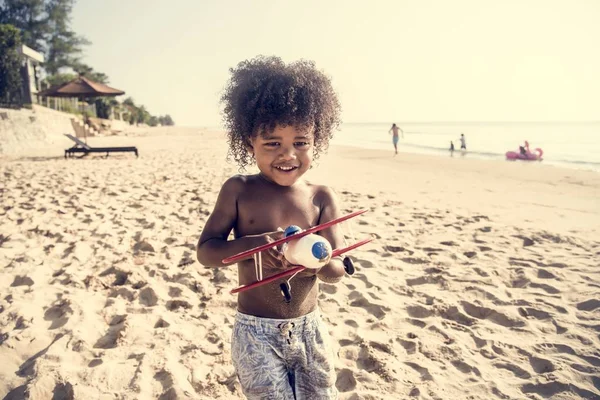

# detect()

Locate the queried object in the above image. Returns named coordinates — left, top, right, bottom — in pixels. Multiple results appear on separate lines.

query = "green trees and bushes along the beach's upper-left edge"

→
left=0, top=0, right=174, bottom=126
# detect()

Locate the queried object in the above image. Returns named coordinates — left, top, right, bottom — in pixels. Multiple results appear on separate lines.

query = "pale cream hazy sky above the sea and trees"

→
left=72, top=0, right=600, bottom=126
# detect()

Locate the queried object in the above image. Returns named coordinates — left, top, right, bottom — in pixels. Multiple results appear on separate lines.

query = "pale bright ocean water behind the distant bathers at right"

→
left=332, top=121, right=600, bottom=171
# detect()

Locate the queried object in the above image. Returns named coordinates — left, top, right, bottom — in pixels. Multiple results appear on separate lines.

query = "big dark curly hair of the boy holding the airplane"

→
left=221, top=56, right=341, bottom=169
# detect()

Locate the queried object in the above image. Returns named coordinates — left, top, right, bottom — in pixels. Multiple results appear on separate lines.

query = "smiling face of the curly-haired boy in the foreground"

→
left=251, top=126, right=314, bottom=186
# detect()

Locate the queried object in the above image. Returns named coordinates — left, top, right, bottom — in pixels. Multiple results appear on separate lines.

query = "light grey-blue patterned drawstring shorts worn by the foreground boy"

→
left=231, top=310, right=337, bottom=400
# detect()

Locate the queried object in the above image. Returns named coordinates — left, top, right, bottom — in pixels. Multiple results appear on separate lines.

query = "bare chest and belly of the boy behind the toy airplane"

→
left=234, top=175, right=321, bottom=319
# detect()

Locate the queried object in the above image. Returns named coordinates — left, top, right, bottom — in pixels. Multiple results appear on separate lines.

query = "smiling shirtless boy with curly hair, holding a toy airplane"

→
left=197, top=57, right=344, bottom=399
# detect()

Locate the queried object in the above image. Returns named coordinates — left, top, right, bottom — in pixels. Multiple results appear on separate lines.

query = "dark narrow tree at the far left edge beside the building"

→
left=0, top=24, right=23, bottom=104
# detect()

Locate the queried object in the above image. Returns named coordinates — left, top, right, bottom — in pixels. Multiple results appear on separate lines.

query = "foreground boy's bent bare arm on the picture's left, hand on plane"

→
left=196, top=176, right=282, bottom=267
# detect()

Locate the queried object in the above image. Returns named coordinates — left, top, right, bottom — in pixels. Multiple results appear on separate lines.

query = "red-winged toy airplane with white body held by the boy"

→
left=223, top=210, right=373, bottom=303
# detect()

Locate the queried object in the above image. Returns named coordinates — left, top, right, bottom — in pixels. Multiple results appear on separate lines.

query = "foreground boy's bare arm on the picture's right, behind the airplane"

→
left=317, top=187, right=346, bottom=283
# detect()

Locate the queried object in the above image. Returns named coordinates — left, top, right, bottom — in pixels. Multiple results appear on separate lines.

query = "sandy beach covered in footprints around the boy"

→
left=0, top=127, right=600, bottom=400
